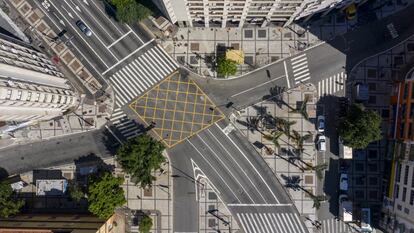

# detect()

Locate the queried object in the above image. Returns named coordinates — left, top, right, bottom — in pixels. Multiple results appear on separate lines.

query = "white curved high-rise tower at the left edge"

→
left=0, top=35, right=79, bottom=122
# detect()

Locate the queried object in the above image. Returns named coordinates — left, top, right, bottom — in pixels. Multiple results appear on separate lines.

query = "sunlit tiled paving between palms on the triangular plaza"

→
left=236, top=85, right=318, bottom=233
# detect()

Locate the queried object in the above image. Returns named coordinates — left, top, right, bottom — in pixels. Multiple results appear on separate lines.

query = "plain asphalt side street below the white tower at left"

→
left=0, top=130, right=115, bottom=175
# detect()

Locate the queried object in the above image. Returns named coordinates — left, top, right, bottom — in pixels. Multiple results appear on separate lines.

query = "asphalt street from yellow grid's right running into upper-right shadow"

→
left=196, top=2, right=414, bottom=109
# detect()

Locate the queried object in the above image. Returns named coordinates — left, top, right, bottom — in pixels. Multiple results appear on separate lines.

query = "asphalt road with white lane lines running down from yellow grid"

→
left=169, top=121, right=307, bottom=232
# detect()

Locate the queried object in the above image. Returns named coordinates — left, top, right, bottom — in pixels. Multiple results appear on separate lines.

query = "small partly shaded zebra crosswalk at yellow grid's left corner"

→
left=109, top=108, right=142, bottom=139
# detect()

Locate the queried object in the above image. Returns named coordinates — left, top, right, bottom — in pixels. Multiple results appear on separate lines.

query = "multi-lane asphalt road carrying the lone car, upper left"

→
left=31, top=0, right=155, bottom=84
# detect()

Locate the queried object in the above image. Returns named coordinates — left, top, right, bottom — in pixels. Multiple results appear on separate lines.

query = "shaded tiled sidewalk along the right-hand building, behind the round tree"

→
left=347, top=34, right=414, bottom=226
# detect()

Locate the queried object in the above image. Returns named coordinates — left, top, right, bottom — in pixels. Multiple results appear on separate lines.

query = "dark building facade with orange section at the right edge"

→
left=381, top=69, right=414, bottom=233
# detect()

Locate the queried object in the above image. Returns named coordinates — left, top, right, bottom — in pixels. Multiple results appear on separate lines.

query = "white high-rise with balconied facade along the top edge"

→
left=153, top=0, right=367, bottom=27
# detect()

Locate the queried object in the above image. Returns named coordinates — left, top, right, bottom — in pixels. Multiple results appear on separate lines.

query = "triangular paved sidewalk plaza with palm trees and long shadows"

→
left=232, top=85, right=318, bottom=232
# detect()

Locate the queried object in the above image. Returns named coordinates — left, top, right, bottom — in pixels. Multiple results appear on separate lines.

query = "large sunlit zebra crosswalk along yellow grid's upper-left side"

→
left=109, top=45, right=178, bottom=107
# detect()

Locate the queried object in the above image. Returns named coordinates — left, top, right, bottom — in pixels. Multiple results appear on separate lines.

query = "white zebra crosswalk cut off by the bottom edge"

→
left=236, top=213, right=307, bottom=233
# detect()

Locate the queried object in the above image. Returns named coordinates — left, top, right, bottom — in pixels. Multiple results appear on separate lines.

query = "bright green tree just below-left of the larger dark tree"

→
left=88, top=172, right=126, bottom=219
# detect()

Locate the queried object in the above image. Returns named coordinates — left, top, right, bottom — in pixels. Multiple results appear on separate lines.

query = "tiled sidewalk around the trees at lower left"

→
left=19, top=156, right=173, bottom=233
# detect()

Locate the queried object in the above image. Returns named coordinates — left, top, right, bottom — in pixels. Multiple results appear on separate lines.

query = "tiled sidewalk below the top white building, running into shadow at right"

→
left=162, top=0, right=414, bottom=76
